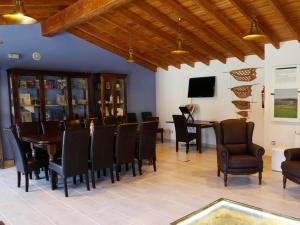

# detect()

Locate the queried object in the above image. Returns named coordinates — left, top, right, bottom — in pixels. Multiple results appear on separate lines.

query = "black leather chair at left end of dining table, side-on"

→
left=4, top=128, right=49, bottom=192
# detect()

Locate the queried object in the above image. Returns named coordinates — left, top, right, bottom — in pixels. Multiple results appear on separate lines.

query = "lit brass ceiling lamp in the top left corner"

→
left=2, top=0, right=37, bottom=25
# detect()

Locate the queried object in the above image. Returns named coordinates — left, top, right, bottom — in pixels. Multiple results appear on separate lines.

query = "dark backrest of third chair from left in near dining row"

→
left=116, top=123, right=138, bottom=164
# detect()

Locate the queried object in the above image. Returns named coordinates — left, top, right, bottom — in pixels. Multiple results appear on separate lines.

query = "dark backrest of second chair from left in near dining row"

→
left=91, top=126, right=116, bottom=170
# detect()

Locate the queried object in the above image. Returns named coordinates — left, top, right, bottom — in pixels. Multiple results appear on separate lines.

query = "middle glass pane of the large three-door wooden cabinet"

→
left=44, top=76, right=68, bottom=121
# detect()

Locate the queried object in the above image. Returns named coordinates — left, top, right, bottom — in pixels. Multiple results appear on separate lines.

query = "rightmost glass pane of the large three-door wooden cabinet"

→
left=71, top=78, right=89, bottom=119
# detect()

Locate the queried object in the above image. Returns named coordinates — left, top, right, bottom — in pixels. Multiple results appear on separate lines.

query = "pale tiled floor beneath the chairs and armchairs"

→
left=0, top=143, right=300, bottom=225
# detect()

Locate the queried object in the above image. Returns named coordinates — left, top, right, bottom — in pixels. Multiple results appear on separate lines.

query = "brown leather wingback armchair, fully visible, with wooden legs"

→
left=214, top=119, right=265, bottom=187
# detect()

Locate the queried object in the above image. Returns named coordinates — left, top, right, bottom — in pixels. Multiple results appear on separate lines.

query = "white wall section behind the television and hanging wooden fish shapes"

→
left=156, top=56, right=264, bottom=148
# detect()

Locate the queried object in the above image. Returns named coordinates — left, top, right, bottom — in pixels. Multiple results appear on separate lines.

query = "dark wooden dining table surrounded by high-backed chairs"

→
left=22, top=134, right=63, bottom=188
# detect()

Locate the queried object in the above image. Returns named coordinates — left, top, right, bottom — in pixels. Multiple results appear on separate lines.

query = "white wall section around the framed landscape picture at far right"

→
left=264, top=41, right=300, bottom=154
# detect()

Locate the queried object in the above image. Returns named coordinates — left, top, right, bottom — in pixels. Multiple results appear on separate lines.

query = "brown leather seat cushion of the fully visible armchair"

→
left=229, top=155, right=258, bottom=169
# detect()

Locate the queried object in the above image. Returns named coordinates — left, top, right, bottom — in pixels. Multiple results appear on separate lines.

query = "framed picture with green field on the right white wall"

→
left=272, top=65, right=300, bottom=122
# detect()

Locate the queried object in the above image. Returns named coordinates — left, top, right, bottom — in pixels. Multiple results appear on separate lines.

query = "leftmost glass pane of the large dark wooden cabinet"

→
left=17, top=76, right=41, bottom=122
